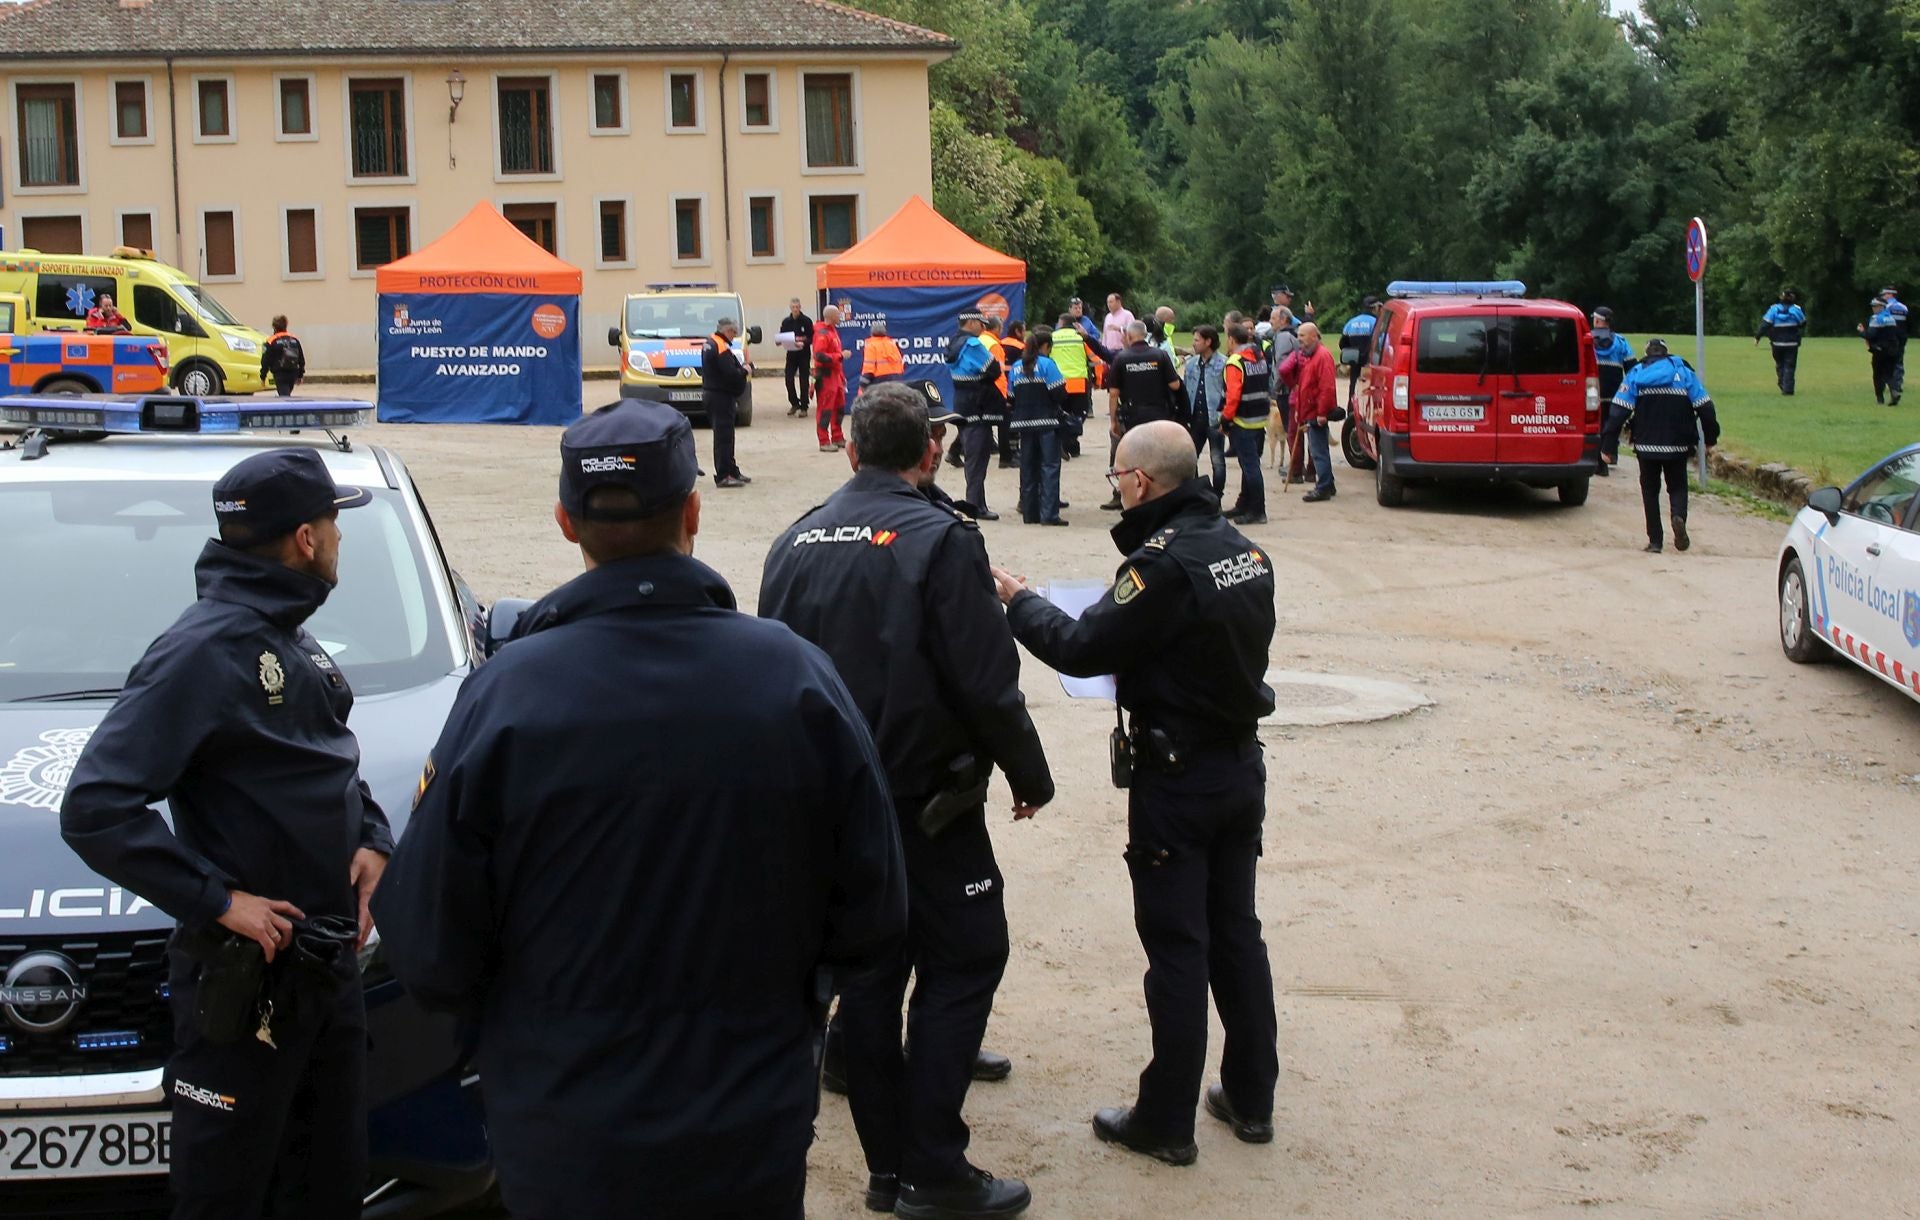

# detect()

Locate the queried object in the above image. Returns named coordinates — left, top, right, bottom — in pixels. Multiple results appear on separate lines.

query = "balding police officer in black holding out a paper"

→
left=993, top=423, right=1281, bottom=1164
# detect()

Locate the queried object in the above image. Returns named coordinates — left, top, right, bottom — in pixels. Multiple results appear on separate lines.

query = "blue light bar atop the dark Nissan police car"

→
left=0, top=394, right=372, bottom=434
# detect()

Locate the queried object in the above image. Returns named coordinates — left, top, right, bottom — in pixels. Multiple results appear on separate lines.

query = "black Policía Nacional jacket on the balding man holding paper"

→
left=1006, top=478, right=1273, bottom=749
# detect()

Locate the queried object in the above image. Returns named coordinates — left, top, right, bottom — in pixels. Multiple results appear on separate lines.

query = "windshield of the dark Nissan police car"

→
left=0, top=480, right=455, bottom=701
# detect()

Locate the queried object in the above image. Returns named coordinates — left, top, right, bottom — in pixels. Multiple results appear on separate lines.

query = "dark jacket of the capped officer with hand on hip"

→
left=60, top=542, right=394, bottom=926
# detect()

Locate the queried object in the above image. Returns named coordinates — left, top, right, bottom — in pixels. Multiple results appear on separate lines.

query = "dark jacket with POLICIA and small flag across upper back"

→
left=760, top=471, right=1054, bottom=813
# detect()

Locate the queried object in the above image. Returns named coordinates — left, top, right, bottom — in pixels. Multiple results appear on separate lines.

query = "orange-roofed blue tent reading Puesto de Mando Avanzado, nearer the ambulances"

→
left=374, top=204, right=582, bottom=425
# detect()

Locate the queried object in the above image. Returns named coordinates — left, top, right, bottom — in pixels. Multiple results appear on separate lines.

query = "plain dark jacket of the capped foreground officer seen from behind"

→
left=374, top=555, right=906, bottom=1216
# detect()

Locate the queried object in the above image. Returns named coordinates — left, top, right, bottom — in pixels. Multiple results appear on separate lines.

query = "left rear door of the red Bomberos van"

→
left=1407, top=305, right=1500, bottom=465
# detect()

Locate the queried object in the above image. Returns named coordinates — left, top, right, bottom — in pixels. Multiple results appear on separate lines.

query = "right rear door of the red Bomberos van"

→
left=1490, top=307, right=1599, bottom=465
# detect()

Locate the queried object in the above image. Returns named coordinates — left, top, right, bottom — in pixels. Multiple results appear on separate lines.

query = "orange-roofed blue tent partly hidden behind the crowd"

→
left=814, top=196, right=1027, bottom=394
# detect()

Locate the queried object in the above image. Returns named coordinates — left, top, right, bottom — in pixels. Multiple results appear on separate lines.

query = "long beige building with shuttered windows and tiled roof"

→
left=0, top=0, right=956, bottom=369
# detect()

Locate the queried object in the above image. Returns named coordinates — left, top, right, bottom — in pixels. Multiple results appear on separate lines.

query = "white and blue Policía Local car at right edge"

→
left=1778, top=444, right=1920, bottom=699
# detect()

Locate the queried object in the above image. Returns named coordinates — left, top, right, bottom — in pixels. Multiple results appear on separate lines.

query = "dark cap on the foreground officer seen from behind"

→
left=561, top=400, right=701, bottom=521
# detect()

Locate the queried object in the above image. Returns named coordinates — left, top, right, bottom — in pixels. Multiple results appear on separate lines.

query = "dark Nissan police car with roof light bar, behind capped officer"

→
left=0, top=396, right=524, bottom=1218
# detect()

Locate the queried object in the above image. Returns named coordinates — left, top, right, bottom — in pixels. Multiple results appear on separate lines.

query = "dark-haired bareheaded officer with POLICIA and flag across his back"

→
left=760, top=384, right=1054, bottom=1218
